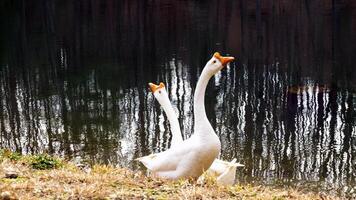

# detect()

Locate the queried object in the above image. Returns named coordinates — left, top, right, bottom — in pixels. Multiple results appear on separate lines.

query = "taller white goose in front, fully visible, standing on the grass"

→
left=137, top=53, right=234, bottom=179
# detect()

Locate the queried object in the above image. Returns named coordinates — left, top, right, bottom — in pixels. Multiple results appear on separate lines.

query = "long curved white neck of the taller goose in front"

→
left=194, top=68, right=212, bottom=126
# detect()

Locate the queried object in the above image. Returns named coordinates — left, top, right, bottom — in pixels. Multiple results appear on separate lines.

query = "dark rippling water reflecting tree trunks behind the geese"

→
left=0, top=0, right=356, bottom=196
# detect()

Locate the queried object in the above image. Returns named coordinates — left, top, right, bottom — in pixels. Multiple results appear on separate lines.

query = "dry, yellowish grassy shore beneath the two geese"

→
left=0, top=150, right=344, bottom=200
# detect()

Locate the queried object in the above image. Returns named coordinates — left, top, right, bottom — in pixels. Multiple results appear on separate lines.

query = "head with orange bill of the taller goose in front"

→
left=205, top=52, right=235, bottom=75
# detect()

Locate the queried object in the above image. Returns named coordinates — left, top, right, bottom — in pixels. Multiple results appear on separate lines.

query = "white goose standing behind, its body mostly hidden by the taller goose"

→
left=148, top=82, right=244, bottom=185
